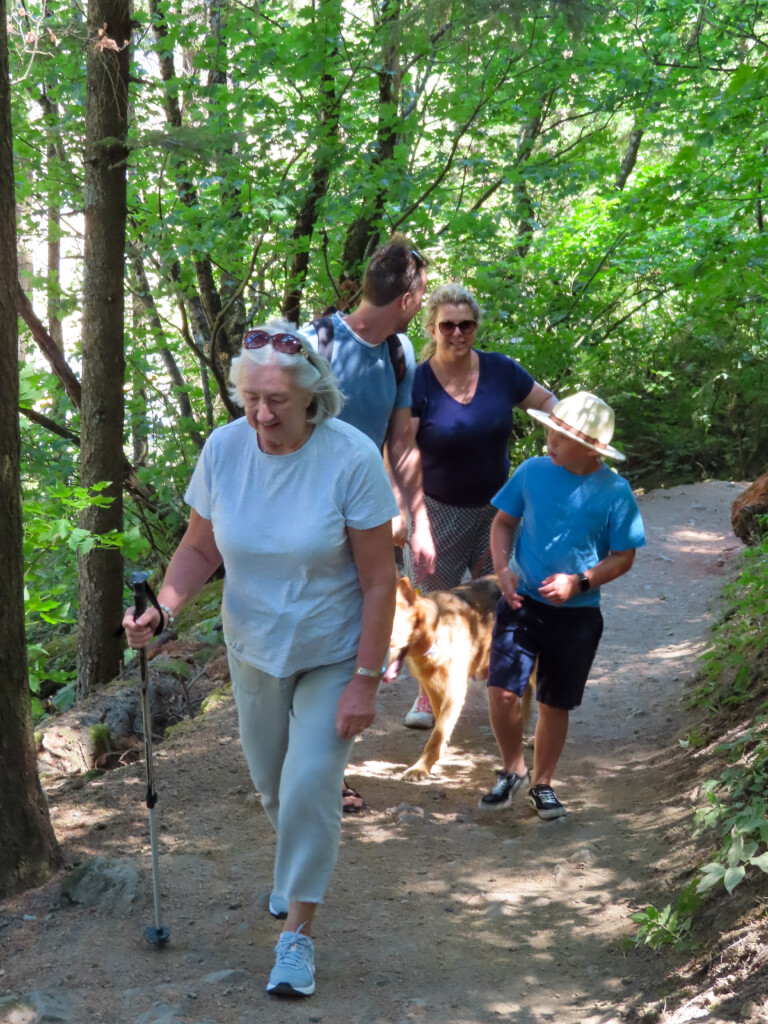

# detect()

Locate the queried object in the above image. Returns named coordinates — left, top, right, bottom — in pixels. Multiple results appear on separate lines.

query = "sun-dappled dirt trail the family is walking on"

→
left=0, top=482, right=740, bottom=1024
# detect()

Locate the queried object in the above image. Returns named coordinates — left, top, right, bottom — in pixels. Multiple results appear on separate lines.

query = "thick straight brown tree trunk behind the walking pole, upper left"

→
left=78, top=0, right=130, bottom=696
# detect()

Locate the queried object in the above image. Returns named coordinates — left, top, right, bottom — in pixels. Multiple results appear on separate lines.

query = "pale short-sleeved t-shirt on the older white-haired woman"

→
left=184, top=418, right=398, bottom=676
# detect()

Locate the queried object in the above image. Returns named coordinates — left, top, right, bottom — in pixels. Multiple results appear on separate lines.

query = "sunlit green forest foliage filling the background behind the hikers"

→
left=8, top=0, right=768, bottom=704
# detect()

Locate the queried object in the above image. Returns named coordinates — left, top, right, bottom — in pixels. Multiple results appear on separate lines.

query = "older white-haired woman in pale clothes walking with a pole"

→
left=124, top=323, right=397, bottom=995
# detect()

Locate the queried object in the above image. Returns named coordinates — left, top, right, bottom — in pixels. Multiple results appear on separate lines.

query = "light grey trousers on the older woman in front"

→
left=228, top=651, right=355, bottom=903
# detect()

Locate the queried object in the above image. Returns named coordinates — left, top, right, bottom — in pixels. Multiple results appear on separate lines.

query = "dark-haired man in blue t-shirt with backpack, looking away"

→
left=302, top=236, right=435, bottom=582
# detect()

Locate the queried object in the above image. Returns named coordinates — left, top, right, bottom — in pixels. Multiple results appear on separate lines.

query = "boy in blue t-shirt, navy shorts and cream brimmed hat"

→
left=478, top=391, right=645, bottom=820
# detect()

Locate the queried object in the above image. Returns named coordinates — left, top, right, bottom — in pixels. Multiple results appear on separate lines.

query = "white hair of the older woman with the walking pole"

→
left=229, top=321, right=344, bottom=424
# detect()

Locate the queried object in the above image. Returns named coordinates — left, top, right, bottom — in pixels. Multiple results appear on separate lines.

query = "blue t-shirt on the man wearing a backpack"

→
left=301, top=313, right=416, bottom=450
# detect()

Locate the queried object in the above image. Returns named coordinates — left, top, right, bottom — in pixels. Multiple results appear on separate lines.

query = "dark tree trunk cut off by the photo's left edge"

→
left=0, top=0, right=62, bottom=899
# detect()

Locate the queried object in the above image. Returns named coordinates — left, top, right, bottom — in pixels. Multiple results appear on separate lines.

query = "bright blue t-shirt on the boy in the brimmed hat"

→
left=493, top=456, right=645, bottom=608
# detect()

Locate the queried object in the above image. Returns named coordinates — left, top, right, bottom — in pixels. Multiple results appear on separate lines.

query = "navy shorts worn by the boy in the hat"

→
left=487, top=597, right=603, bottom=711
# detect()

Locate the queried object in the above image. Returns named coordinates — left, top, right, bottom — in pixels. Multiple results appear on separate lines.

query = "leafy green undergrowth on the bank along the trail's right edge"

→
left=627, top=539, right=768, bottom=949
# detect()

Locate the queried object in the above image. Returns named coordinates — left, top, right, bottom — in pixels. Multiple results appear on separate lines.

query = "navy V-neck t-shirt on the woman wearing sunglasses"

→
left=411, top=349, right=535, bottom=508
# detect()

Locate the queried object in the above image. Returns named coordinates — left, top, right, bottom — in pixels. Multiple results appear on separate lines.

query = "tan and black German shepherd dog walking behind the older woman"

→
left=384, top=575, right=531, bottom=780
